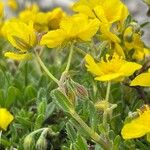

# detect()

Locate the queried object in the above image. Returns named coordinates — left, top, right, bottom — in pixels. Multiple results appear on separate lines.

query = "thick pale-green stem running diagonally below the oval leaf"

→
left=70, top=110, right=109, bottom=150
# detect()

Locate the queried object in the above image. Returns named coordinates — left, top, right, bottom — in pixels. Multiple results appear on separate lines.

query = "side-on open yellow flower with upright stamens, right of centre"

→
left=85, top=54, right=142, bottom=81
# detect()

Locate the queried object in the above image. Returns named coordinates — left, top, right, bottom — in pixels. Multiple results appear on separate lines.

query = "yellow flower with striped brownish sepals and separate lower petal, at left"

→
left=2, top=19, right=36, bottom=60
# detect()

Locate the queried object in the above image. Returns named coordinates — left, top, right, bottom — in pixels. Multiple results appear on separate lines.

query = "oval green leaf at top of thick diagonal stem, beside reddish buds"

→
left=51, top=89, right=74, bottom=112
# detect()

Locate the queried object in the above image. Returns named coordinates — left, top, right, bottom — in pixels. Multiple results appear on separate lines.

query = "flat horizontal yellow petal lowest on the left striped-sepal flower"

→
left=4, top=52, right=32, bottom=61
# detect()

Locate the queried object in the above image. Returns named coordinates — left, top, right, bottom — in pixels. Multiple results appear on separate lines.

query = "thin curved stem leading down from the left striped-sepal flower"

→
left=35, top=52, right=59, bottom=85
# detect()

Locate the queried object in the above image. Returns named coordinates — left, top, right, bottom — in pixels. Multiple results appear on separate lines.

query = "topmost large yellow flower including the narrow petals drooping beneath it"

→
left=72, top=0, right=129, bottom=57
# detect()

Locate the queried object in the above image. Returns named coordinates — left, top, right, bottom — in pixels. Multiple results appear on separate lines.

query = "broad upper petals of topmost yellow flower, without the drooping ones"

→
left=72, top=0, right=129, bottom=23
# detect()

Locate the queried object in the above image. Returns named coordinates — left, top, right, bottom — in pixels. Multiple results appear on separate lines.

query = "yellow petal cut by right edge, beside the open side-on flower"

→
left=130, top=73, right=150, bottom=86
